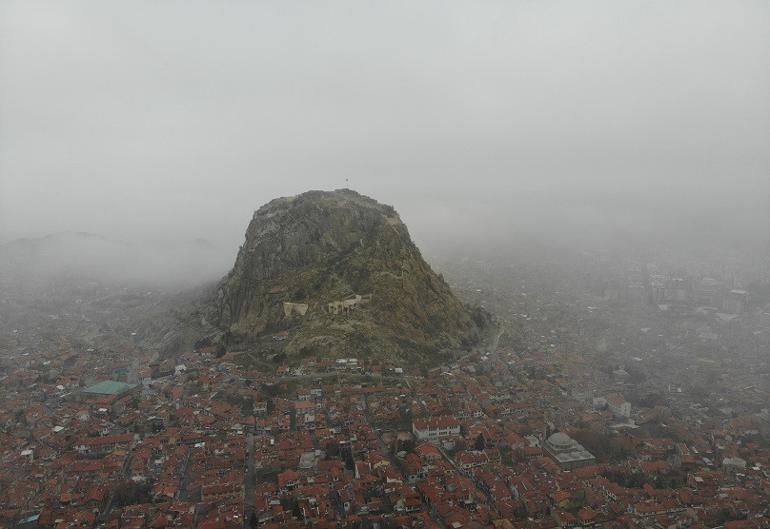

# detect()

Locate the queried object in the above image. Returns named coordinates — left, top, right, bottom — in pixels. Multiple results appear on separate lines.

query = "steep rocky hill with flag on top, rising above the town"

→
left=213, top=190, right=489, bottom=362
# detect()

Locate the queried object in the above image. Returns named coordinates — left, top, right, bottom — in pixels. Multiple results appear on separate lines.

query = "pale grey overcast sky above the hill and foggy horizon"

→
left=0, top=0, right=770, bottom=254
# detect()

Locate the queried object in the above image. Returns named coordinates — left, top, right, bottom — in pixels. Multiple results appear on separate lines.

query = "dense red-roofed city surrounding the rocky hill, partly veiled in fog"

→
left=0, top=248, right=770, bottom=529
